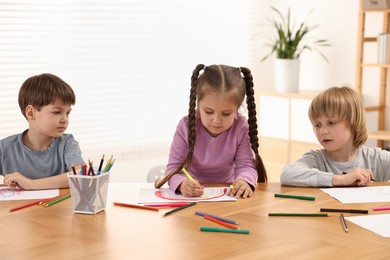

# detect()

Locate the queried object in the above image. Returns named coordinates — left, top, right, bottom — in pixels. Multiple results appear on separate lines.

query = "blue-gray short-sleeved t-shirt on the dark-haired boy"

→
left=0, top=130, right=83, bottom=179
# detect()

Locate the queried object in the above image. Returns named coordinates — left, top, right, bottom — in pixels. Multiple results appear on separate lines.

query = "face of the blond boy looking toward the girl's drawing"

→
left=313, top=115, right=354, bottom=156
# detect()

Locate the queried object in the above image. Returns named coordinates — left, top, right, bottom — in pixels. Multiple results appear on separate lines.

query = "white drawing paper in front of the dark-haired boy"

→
left=0, top=187, right=60, bottom=201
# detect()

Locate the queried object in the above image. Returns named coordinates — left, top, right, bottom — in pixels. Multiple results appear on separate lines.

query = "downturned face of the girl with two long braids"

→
left=198, top=92, right=238, bottom=137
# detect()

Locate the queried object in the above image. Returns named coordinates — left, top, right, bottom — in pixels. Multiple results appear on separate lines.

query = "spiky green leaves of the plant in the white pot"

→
left=261, top=7, right=330, bottom=61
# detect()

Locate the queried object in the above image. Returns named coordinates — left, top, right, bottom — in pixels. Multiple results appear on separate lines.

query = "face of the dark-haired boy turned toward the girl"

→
left=33, top=100, right=71, bottom=138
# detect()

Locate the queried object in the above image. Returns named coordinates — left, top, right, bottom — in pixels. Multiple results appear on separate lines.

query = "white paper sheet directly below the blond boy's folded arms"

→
left=321, top=186, right=390, bottom=203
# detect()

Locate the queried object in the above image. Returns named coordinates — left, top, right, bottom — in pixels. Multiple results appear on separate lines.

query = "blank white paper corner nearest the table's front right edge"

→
left=345, top=214, right=390, bottom=237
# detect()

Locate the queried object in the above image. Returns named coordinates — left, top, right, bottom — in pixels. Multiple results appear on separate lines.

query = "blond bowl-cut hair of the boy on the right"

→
left=309, top=86, right=368, bottom=147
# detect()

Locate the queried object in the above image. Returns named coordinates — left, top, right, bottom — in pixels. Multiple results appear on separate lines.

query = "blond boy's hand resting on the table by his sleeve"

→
left=332, top=169, right=372, bottom=186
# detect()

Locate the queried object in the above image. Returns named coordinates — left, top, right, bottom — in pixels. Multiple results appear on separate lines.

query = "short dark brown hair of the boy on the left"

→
left=18, top=73, right=76, bottom=117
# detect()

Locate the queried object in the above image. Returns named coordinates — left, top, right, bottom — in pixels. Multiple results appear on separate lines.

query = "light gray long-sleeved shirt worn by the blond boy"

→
left=280, top=146, right=390, bottom=187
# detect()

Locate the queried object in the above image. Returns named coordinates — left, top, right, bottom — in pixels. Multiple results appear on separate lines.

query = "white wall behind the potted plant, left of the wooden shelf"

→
left=254, top=0, right=359, bottom=91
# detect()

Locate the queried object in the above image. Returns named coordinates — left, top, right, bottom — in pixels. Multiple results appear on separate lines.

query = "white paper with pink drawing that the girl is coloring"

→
left=138, top=187, right=237, bottom=204
